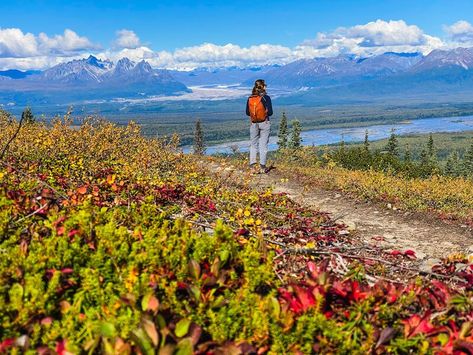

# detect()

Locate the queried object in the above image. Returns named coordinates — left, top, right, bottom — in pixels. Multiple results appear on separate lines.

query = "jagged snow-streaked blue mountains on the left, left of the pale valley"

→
left=0, top=55, right=190, bottom=103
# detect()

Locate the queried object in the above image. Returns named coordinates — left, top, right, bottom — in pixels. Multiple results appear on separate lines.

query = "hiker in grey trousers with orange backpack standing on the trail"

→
left=246, top=79, right=273, bottom=173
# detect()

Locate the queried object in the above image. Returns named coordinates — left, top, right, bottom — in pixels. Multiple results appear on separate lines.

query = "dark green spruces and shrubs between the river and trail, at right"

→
left=326, top=130, right=473, bottom=178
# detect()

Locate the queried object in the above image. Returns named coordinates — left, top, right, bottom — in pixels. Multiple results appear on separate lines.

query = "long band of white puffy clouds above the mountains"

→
left=0, top=20, right=473, bottom=70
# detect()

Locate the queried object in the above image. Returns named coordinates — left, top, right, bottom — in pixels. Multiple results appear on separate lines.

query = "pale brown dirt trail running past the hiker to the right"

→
left=210, top=164, right=473, bottom=263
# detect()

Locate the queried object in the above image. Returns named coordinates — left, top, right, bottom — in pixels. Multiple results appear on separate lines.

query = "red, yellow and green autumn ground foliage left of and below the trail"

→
left=0, top=118, right=473, bottom=354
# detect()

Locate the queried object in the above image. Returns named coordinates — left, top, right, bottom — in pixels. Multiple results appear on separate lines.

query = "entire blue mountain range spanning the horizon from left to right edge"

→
left=0, top=48, right=473, bottom=105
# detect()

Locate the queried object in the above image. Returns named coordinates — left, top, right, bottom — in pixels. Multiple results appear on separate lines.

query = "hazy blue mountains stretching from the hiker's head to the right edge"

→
left=256, top=48, right=473, bottom=104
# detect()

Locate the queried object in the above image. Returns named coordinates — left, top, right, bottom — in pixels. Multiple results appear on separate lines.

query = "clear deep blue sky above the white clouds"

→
left=0, top=0, right=473, bottom=50
